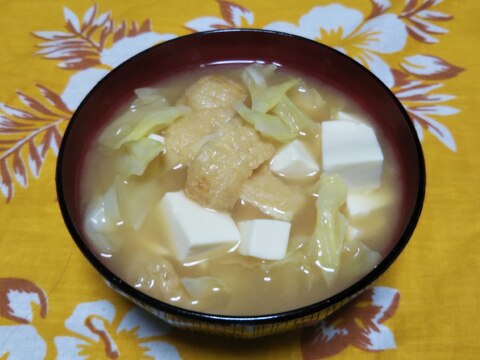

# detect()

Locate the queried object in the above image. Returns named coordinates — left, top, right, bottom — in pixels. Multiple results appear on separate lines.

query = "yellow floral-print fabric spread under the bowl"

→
left=0, top=0, right=480, bottom=359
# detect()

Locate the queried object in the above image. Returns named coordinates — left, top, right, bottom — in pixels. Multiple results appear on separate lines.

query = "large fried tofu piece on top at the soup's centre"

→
left=185, top=117, right=275, bottom=210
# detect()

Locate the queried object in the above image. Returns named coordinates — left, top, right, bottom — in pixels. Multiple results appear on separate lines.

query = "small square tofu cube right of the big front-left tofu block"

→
left=238, top=219, right=291, bottom=260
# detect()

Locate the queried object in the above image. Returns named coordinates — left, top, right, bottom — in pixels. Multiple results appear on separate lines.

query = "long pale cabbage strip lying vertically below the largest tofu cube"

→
left=306, top=175, right=347, bottom=285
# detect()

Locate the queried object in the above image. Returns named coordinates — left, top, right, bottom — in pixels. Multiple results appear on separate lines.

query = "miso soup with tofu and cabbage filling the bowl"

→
left=81, top=64, right=402, bottom=316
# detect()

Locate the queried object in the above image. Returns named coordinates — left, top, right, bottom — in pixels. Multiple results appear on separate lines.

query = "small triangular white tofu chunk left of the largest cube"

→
left=270, top=140, right=320, bottom=178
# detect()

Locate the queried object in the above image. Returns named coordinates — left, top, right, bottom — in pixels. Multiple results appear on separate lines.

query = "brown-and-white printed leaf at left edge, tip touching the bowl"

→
left=0, top=84, right=72, bottom=203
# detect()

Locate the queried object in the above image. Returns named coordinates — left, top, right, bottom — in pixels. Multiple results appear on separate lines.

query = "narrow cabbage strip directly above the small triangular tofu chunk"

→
left=235, top=102, right=298, bottom=142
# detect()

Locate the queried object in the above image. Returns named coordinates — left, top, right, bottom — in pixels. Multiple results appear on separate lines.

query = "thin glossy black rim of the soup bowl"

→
left=55, top=28, right=426, bottom=326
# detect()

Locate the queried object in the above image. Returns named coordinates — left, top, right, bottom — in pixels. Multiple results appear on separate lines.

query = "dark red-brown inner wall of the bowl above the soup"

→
left=57, top=30, right=425, bottom=319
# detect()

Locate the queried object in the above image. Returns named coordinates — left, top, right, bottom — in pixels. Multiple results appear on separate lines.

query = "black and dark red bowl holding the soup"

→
left=56, top=29, right=425, bottom=338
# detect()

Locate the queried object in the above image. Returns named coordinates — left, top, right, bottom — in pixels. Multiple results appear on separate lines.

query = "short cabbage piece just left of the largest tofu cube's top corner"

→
left=272, top=95, right=318, bottom=134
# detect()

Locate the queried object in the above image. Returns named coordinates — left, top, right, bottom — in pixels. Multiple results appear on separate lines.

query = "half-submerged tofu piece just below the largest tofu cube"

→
left=346, top=189, right=393, bottom=217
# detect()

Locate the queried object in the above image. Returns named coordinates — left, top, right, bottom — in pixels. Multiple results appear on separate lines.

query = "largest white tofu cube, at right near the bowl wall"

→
left=322, top=120, right=383, bottom=190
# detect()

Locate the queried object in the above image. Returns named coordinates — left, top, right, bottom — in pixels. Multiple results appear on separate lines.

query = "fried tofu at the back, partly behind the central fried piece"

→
left=164, top=76, right=247, bottom=166
